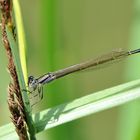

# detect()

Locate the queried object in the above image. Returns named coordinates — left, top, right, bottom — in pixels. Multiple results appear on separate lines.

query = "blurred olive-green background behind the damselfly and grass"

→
left=0, top=0, right=140, bottom=140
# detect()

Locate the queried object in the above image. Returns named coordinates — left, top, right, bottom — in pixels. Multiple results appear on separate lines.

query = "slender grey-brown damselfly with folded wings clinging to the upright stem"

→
left=28, top=49, right=140, bottom=105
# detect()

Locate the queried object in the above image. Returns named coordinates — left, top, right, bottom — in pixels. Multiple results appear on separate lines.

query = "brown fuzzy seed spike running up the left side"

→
left=0, top=0, right=28, bottom=140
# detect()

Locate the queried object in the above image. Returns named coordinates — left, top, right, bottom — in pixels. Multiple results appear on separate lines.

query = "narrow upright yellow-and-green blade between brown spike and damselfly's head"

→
left=8, top=0, right=35, bottom=139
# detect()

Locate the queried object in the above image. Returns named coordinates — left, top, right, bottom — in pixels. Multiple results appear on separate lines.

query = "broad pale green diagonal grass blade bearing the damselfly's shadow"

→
left=0, top=79, right=140, bottom=138
